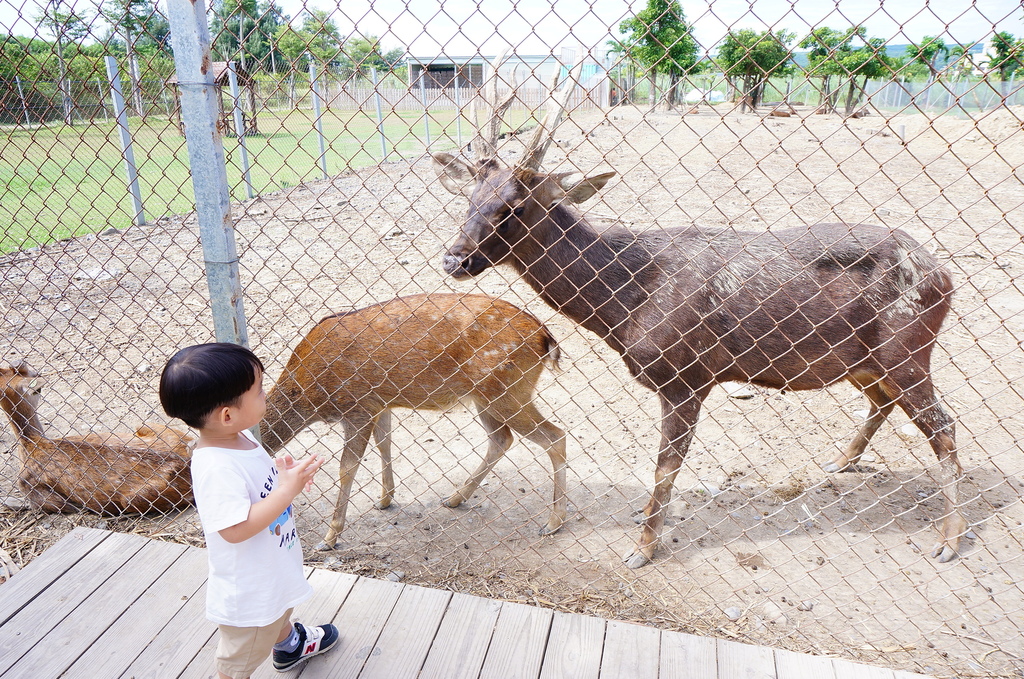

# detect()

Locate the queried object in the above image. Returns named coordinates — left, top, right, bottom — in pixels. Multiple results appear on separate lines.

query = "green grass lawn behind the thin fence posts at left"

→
left=0, top=110, right=525, bottom=253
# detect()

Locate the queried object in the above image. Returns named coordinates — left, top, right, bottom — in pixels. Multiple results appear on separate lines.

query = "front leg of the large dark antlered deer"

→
left=624, top=389, right=708, bottom=568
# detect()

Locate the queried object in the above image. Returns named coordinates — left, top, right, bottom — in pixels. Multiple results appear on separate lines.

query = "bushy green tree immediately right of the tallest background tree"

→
left=717, top=29, right=797, bottom=107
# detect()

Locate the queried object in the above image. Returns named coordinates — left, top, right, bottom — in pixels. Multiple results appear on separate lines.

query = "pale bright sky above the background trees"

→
left=0, top=0, right=1024, bottom=56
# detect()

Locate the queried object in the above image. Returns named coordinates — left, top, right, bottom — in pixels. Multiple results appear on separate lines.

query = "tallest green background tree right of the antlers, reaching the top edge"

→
left=614, top=0, right=698, bottom=108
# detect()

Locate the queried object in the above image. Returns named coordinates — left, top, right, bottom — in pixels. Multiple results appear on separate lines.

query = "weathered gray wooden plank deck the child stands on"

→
left=0, top=528, right=937, bottom=679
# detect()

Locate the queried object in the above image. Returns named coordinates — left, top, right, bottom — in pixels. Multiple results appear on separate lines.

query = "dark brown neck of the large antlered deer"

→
left=513, top=206, right=650, bottom=350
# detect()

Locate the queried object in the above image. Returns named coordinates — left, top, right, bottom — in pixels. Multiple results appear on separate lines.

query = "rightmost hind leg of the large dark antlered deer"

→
left=896, top=370, right=968, bottom=563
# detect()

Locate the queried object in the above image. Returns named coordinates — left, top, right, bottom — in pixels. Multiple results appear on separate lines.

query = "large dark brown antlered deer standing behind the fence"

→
left=433, top=58, right=967, bottom=567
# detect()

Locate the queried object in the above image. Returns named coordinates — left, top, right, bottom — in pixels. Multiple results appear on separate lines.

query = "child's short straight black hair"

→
left=160, top=342, right=264, bottom=429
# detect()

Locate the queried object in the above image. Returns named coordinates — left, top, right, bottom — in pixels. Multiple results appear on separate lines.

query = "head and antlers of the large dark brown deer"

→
left=433, top=53, right=615, bottom=279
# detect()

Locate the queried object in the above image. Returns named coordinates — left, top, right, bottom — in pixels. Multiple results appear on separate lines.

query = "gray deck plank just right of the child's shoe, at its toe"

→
left=302, top=578, right=404, bottom=679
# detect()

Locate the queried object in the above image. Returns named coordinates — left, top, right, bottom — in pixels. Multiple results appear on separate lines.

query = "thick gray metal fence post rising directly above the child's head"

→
left=167, top=0, right=249, bottom=346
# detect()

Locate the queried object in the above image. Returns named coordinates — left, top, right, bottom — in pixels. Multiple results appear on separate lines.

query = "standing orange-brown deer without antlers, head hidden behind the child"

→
left=261, top=294, right=566, bottom=550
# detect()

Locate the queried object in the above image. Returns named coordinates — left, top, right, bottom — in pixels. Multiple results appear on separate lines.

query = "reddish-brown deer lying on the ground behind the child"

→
left=0, top=363, right=194, bottom=515
